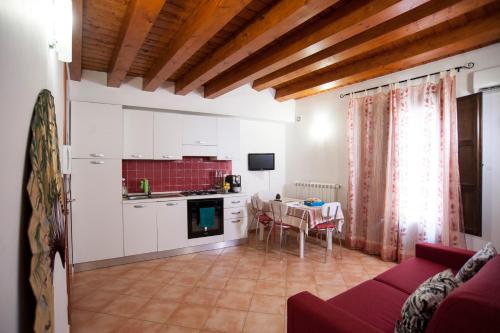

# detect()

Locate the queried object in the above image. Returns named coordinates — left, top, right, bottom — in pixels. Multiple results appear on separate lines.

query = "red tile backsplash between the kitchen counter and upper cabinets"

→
left=122, top=157, right=232, bottom=193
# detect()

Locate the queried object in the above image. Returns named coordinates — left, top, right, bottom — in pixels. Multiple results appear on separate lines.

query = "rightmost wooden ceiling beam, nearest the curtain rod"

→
left=275, top=11, right=500, bottom=101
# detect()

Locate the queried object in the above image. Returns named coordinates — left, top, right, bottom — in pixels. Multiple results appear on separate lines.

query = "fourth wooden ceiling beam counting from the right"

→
left=175, top=0, right=338, bottom=95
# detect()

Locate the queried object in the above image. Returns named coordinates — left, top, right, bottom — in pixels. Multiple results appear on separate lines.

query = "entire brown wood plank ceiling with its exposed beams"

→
left=70, top=0, right=500, bottom=101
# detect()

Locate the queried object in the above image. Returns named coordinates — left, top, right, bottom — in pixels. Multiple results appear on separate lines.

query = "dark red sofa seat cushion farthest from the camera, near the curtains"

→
left=375, top=257, right=448, bottom=294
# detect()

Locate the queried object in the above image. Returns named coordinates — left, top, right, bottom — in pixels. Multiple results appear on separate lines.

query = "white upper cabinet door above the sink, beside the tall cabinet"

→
left=123, top=110, right=154, bottom=160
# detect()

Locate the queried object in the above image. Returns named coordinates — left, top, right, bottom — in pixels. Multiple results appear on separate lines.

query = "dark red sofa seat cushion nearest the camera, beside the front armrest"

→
left=327, top=280, right=408, bottom=333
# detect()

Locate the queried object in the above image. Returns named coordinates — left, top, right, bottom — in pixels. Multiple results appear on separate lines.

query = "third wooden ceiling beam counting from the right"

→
left=201, top=0, right=429, bottom=98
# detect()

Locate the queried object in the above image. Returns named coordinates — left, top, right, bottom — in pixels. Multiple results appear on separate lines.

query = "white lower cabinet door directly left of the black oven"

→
left=156, top=200, right=188, bottom=251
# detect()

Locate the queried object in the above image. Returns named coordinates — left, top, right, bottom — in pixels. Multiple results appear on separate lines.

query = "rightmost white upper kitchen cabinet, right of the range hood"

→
left=217, top=118, right=240, bottom=160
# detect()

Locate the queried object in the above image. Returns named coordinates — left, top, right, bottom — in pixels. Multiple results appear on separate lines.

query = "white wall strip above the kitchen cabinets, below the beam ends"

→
left=70, top=71, right=295, bottom=121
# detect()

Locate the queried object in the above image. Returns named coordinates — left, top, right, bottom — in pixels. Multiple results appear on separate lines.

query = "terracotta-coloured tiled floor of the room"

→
left=71, top=233, right=394, bottom=333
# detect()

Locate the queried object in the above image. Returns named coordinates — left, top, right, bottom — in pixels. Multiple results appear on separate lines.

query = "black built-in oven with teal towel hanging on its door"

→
left=188, top=198, right=224, bottom=239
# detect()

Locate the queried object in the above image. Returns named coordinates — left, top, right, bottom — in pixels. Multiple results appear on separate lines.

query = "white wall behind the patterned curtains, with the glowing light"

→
left=286, top=43, right=500, bottom=249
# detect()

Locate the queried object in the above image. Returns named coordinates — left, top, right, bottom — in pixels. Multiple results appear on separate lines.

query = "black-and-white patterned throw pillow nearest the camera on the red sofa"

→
left=394, top=269, right=460, bottom=333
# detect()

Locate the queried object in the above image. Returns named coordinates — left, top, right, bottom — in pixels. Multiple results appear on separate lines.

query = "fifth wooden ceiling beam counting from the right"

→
left=143, top=0, right=254, bottom=91
